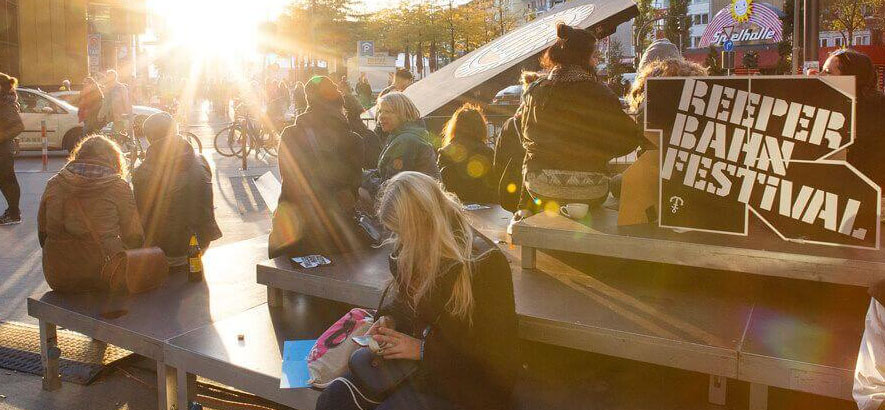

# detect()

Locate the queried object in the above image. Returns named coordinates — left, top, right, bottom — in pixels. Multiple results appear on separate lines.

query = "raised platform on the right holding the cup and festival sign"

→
left=513, top=207, right=885, bottom=286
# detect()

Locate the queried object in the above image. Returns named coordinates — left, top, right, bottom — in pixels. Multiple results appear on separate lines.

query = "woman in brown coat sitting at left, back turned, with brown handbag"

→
left=37, top=135, right=144, bottom=292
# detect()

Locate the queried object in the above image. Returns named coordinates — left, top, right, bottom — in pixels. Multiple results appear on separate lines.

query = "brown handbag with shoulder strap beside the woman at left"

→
left=72, top=198, right=169, bottom=293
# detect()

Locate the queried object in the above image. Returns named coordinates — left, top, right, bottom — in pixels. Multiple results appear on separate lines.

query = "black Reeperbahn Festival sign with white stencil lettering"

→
left=645, top=76, right=881, bottom=249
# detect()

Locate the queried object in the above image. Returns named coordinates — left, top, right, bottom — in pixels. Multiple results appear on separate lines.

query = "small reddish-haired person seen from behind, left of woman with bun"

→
left=437, top=104, right=495, bottom=204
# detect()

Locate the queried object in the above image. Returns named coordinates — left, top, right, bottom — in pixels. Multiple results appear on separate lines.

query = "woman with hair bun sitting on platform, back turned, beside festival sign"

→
left=516, top=23, right=640, bottom=215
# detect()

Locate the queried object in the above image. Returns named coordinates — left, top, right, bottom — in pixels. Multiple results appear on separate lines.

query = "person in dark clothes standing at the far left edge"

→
left=0, top=73, right=25, bottom=226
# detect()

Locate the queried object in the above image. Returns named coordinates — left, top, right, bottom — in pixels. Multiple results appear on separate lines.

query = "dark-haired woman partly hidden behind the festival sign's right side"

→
left=821, top=49, right=885, bottom=187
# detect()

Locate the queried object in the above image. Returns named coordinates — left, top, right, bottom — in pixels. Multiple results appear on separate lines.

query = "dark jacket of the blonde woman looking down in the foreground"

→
left=379, top=231, right=518, bottom=410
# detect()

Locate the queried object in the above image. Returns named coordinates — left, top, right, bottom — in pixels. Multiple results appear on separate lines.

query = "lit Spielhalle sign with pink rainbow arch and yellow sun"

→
left=698, top=0, right=783, bottom=48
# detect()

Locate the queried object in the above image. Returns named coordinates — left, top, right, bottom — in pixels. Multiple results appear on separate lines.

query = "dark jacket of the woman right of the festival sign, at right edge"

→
left=848, top=94, right=885, bottom=189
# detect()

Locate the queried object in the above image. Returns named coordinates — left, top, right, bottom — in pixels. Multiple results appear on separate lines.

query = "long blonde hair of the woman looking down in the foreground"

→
left=378, top=171, right=481, bottom=323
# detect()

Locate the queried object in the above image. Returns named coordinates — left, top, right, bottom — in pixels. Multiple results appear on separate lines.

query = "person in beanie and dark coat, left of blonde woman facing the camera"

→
left=268, top=76, right=363, bottom=258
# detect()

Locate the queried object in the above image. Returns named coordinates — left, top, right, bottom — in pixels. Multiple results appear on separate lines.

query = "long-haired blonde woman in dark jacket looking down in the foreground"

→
left=316, top=171, right=517, bottom=410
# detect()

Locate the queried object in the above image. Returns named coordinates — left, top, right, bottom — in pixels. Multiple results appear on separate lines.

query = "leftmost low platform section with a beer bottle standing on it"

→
left=28, top=237, right=267, bottom=409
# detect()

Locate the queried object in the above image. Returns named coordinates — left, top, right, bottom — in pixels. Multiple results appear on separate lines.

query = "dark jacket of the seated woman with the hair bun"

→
left=521, top=71, right=641, bottom=172
